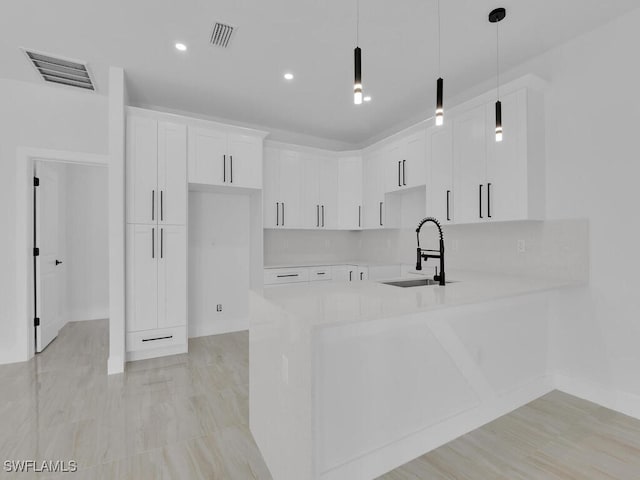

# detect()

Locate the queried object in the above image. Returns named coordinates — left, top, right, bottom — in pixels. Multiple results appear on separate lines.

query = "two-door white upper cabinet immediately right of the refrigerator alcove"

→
left=263, top=147, right=304, bottom=228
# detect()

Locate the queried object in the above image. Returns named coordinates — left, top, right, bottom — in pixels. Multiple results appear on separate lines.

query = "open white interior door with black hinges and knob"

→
left=34, top=162, right=64, bottom=352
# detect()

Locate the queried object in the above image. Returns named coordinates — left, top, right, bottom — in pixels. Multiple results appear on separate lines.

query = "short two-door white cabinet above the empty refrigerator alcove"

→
left=189, top=126, right=262, bottom=188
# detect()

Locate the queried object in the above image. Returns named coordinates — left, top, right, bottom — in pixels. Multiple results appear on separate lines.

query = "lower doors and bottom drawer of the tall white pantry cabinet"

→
left=126, top=224, right=187, bottom=360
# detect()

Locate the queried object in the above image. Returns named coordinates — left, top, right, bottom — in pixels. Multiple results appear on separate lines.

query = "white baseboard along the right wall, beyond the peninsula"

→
left=554, top=374, right=640, bottom=419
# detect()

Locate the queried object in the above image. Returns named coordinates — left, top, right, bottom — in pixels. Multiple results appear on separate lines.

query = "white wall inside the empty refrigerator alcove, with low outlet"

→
left=188, top=191, right=251, bottom=337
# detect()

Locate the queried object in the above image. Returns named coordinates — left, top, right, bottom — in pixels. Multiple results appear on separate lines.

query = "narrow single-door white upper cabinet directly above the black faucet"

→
left=427, top=124, right=454, bottom=224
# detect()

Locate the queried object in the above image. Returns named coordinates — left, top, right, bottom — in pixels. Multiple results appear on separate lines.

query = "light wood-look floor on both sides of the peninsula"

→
left=0, top=321, right=640, bottom=480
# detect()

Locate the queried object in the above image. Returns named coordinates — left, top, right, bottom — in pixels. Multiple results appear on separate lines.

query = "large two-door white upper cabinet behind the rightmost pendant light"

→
left=448, top=88, right=544, bottom=223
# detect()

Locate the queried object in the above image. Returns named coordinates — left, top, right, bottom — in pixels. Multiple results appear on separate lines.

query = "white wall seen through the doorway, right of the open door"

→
left=65, top=164, right=109, bottom=322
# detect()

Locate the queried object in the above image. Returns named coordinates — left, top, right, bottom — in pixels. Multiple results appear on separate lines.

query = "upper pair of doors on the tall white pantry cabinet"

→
left=126, top=115, right=187, bottom=225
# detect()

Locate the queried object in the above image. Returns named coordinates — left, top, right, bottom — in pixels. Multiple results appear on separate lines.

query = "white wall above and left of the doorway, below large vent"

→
left=0, top=80, right=107, bottom=363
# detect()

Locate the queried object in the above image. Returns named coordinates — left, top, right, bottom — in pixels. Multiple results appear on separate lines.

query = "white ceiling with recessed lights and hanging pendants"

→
left=0, top=0, right=638, bottom=146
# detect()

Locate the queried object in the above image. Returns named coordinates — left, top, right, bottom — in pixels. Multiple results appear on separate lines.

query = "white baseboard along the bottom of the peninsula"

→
left=319, top=376, right=554, bottom=480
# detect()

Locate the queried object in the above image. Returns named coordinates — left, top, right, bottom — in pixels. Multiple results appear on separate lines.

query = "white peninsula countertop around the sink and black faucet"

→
left=263, top=270, right=582, bottom=325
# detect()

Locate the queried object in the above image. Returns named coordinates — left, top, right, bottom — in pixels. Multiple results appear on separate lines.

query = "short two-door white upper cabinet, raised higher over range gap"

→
left=385, top=130, right=427, bottom=192
